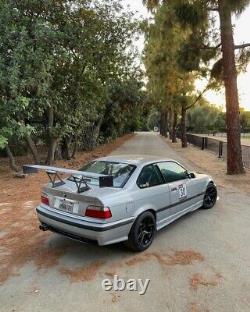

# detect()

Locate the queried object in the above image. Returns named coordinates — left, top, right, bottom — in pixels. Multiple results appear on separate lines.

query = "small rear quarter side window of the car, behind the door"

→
left=137, top=165, right=163, bottom=188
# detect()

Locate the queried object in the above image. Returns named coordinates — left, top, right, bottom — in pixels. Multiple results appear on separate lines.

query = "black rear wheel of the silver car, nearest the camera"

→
left=127, top=211, right=156, bottom=251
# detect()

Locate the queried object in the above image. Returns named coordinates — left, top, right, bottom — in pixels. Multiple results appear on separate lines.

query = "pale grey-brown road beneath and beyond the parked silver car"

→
left=0, top=133, right=250, bottom=312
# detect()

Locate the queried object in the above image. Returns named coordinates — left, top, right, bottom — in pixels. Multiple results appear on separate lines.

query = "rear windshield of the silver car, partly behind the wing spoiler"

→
left=80, top=161, right=136, bottom=187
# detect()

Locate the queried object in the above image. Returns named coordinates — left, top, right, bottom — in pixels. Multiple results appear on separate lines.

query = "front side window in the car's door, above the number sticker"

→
left=157, top=161, right=187, bottom=183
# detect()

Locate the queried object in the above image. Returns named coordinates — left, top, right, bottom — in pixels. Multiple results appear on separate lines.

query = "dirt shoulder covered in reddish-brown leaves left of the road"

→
left=0, top=134, right=133, bottom=285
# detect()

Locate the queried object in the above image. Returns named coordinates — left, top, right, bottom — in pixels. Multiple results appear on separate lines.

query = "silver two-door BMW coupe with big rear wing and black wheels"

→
left=27, top=155, right=217, bottom=251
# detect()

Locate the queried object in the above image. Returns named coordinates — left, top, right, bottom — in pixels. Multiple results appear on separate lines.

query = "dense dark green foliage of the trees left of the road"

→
left=0, top=0, right=145, bottom=161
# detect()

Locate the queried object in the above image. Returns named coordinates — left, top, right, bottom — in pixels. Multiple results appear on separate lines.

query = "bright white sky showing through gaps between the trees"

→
left=123, top=0, right=250, bottom=110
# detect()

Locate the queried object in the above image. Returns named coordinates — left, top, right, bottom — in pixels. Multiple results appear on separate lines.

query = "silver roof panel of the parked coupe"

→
left=97, top=154, right=175, bottom=165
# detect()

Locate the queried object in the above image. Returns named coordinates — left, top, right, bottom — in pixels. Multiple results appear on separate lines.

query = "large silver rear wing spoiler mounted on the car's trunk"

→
left=23, top=165, right=113, bottom=193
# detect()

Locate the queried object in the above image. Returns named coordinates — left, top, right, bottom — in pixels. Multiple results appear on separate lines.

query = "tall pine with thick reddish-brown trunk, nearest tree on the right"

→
left=144, top=0, right=250, bottom=174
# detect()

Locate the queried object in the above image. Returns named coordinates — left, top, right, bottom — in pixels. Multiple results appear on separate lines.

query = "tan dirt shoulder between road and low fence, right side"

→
left=164, top=139, right=250, bottom=194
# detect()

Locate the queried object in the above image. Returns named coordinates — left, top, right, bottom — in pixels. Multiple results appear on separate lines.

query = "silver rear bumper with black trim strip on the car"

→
left=36, top=205, right=134, bottom=245
